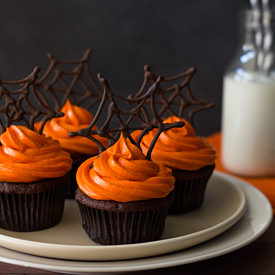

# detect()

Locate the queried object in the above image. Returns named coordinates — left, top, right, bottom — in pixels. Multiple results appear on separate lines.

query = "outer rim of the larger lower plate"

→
left=0, top=172, right=273, bottom=274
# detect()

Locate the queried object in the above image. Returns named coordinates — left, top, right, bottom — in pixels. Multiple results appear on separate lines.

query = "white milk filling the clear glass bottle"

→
left=222, top=73, right=275, bottom=176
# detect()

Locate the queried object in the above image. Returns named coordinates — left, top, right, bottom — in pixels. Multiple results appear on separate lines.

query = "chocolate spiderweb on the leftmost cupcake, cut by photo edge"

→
left=0, top=67, right=63, bottom=133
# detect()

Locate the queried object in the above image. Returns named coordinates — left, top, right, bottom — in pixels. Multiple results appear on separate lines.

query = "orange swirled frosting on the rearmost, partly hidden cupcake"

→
left=35, top=100, right=107, bottom=155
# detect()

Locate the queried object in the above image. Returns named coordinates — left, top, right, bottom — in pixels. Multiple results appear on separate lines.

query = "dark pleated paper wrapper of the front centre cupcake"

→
left=79, top=204, right=167, bottom=245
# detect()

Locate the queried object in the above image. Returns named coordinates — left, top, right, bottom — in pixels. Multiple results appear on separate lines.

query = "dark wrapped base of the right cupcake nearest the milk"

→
left=169, top=165, right=215, bottom=214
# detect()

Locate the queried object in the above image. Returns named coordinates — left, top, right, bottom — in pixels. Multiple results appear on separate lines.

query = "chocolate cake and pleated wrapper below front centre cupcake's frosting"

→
left=76, top=188, right=174, bottom=245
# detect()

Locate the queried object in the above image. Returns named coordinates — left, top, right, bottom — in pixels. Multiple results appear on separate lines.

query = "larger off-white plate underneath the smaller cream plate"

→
left=0, top=172, right=273, bottom=274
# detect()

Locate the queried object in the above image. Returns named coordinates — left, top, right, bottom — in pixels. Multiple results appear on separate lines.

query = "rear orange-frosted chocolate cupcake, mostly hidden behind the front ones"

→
left=35, top=99, right=107, bottom=198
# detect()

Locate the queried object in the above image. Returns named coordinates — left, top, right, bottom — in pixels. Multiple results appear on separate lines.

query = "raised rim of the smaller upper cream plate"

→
left=0, top=174, right=246, bottom=261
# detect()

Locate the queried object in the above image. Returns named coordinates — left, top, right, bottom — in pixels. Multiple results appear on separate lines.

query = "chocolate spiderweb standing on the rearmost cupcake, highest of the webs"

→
left=36, top=49, right=102, bottom=111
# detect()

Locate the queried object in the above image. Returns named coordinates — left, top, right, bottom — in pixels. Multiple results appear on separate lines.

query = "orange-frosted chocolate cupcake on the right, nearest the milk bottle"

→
left=136, top=116, right=216, bottom=213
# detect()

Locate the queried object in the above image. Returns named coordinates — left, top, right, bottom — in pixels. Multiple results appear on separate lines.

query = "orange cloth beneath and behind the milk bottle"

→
left=207, top=133, right=275, bottom=215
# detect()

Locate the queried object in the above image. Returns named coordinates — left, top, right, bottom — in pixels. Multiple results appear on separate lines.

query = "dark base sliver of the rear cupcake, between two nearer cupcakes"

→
left=66, top=154, right=93, bottom=199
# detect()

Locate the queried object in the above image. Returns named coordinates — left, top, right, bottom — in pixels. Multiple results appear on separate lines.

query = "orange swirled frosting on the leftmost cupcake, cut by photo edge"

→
left=0, top=125, right=72, bottom=182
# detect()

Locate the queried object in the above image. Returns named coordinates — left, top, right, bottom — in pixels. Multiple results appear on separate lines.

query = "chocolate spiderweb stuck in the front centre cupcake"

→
left=70, top=74, right=184, bottom=159
